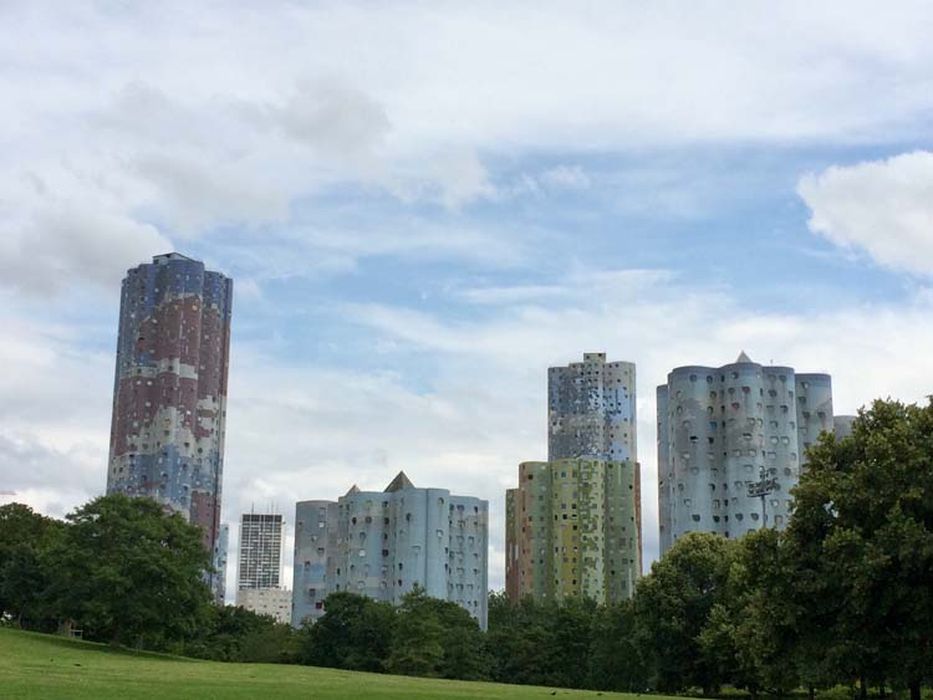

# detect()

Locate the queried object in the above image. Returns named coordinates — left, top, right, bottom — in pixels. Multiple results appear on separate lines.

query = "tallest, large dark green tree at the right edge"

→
left=787, top=400, right=933, bottom=700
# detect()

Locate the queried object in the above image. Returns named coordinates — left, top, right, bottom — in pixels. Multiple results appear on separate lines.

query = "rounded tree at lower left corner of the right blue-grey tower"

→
left=634, top=532, right=735, bottom=694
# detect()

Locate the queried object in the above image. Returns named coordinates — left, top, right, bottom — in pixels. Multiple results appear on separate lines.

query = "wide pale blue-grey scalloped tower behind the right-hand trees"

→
left=657, top=352, right=851, bottom=554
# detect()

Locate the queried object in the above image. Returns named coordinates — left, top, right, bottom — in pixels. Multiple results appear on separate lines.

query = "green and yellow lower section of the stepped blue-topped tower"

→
left=505, top=459, right=641, bottom=603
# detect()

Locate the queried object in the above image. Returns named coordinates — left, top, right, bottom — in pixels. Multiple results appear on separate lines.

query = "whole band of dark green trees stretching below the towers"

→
left=0, top=401, right=933, bottom=700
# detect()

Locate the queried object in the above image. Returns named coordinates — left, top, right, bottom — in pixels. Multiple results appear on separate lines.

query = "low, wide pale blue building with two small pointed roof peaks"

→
left=292, top=472, right=489, bottom=629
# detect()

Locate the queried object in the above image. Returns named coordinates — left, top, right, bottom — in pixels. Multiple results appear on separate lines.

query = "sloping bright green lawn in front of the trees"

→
left=0, top=629, right=658, bottom=700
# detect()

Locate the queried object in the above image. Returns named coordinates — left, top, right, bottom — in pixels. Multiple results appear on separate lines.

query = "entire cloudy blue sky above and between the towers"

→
left=0, top=0, right=933, bottom=600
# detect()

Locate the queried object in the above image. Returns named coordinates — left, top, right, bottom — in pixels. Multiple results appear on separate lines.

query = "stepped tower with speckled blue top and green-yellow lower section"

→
left=505, top=353, right=641, bottom=603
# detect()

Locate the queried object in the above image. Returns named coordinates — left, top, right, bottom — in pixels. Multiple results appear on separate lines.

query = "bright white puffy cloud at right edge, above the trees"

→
left=797, top=151, right=933, bottom=274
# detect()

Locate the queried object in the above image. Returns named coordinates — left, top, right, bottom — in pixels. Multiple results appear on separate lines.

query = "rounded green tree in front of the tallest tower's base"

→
left=47, top=494, right=210, bottom=647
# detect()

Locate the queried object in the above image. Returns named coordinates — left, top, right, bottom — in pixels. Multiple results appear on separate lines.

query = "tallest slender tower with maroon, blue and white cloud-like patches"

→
left=107, top=253, right=233, bottom=600
